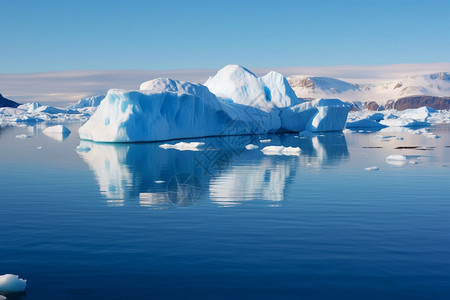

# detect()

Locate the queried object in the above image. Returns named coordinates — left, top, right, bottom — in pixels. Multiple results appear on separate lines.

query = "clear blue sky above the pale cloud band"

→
left=0, top=0, right=450, bottom=74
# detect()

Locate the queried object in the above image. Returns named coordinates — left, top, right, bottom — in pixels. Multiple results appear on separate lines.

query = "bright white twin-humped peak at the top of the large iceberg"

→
left=205, top=65, right=301, bottom=112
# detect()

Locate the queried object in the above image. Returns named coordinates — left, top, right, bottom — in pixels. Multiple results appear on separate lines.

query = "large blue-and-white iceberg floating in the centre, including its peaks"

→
left=79, top=65, right=350, bottom=142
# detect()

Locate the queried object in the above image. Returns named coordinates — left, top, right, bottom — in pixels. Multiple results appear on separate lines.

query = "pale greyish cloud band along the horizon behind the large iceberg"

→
left=0, top=63, right=450, bottom=106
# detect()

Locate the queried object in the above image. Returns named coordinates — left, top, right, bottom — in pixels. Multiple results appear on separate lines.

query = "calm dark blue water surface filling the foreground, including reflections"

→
left=0, top=126, right=450, bottom=299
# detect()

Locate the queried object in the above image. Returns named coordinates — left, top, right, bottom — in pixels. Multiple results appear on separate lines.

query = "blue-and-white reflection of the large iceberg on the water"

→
left=77, top=133, right=348, bottom=209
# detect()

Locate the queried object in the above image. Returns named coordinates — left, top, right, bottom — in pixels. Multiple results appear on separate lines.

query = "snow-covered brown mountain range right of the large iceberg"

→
left=287, top=72, right=450, bottom=110
